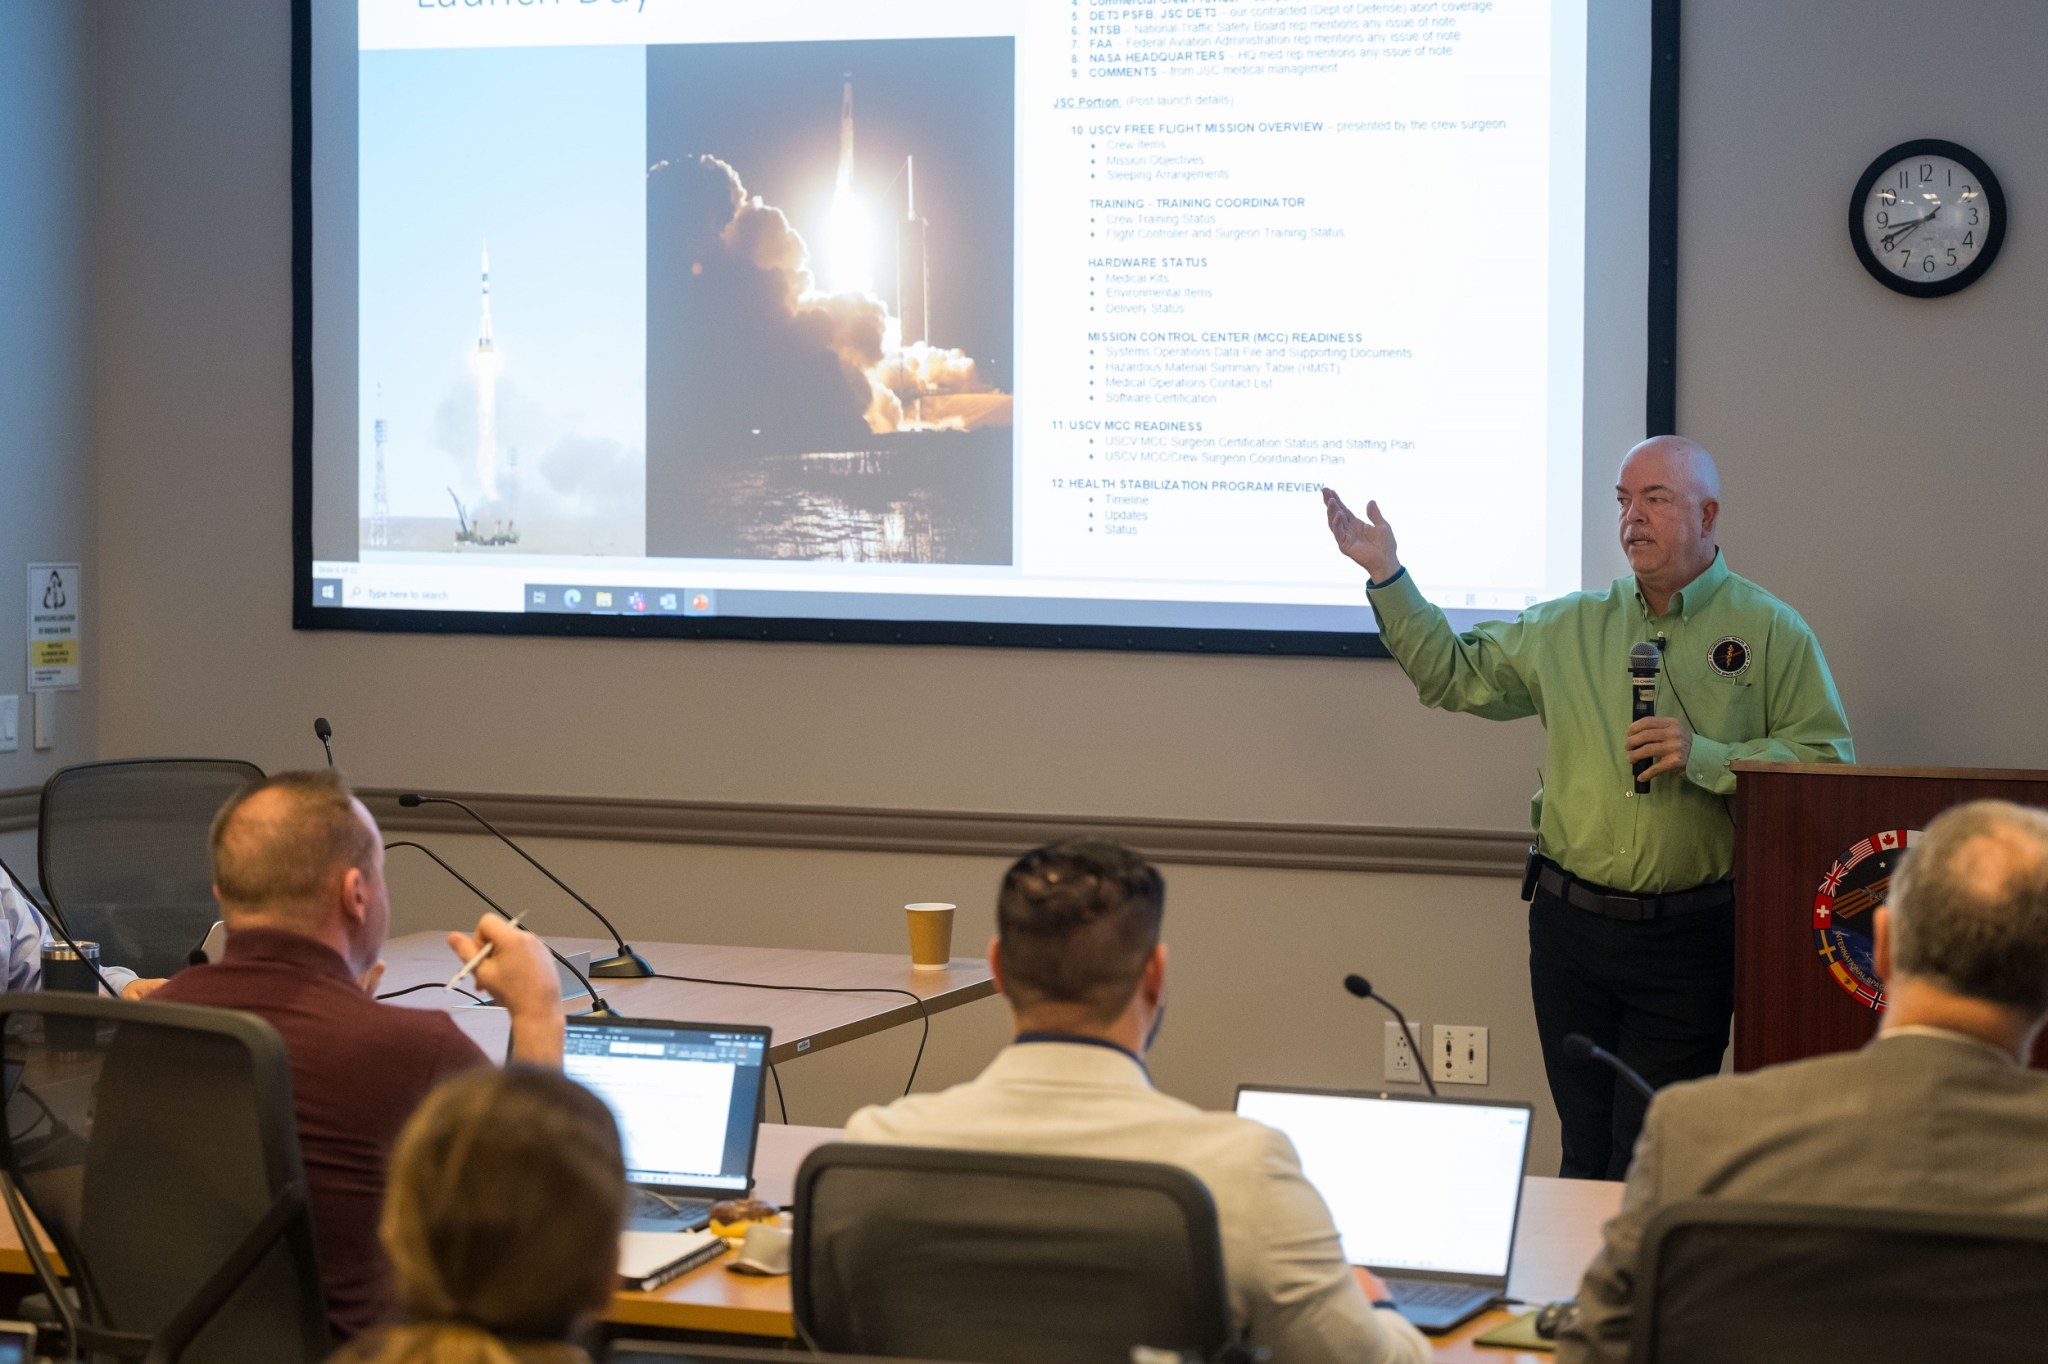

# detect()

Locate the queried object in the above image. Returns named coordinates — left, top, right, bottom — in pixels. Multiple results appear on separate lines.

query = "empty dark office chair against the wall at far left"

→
left=37, top=758, right=262, bottom=977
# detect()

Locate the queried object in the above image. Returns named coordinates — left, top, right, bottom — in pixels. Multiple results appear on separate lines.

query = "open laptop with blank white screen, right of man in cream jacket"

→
left=1237, top=1085, right=1530, bottom=1333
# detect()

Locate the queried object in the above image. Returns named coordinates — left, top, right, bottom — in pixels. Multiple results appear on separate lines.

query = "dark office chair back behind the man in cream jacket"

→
left=791, top=1143, right=1231, bottom=1364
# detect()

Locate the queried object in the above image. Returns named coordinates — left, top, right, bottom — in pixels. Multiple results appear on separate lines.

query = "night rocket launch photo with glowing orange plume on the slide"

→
left=647, top=39, right=1016, bottom=563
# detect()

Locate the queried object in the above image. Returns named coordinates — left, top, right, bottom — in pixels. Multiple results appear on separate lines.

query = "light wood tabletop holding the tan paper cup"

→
left=377, top=932, right=995, bottom=1063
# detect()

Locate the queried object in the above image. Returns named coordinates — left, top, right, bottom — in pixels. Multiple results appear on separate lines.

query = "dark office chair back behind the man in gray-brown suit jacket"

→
left=1628, top=1198, right=2048, bottom=1364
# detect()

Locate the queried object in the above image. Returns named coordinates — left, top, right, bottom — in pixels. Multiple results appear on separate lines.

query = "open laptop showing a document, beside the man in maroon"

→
left=561, top=1018, right=768, bottom=1231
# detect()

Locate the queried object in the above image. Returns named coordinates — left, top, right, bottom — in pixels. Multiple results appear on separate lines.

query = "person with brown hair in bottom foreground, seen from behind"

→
left=336, top=1065, right=627, bottom=1364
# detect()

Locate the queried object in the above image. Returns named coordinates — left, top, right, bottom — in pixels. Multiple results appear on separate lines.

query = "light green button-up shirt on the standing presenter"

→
left=1368, top=555, right=1855, bottom=895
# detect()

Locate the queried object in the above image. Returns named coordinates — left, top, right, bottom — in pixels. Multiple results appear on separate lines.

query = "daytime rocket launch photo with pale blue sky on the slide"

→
left=356, top=47, right=647, bottom=557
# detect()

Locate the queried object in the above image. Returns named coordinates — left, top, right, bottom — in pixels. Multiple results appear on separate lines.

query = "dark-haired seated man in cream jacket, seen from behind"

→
left=846, top=842, right=1430, bottom=1364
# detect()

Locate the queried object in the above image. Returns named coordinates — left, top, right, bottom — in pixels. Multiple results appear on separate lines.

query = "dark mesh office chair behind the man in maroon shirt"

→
left=0, top=993, right=330, bottom=1364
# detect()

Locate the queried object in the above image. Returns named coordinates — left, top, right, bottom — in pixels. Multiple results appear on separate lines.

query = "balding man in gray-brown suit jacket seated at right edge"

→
left=1556, top=801, right=2048, bottom=1364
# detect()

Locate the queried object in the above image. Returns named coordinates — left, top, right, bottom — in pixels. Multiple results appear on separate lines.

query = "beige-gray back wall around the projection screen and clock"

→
left=39, top=0, right=2048, bottom=1167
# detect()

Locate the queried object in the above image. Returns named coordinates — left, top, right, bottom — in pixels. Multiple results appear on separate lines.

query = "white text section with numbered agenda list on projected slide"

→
left=1018, top=0, right=1579, bottom=590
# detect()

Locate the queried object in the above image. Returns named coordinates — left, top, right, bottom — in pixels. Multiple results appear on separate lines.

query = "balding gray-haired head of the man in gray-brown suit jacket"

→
left=1884, top=801, right=2048, bottom=1016
